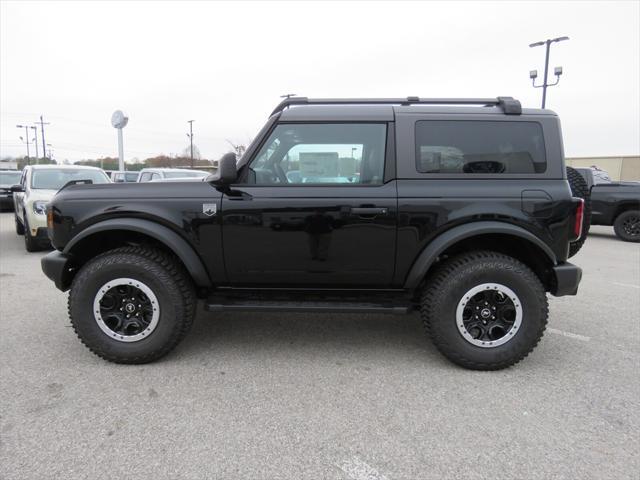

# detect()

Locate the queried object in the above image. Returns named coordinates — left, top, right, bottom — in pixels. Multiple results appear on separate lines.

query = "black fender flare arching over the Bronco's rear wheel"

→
left=404, top=221, right=558, bottom=290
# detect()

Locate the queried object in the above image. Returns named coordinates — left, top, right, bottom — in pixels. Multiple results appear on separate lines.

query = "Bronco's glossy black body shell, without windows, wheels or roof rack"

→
left=43, top=106, right=579, bottom=292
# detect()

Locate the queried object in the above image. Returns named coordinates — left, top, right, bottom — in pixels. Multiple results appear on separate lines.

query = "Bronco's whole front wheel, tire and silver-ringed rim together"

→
left=69, top=247, right=196, bottom=363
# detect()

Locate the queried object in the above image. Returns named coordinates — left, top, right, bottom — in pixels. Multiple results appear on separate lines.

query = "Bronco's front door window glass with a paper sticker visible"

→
left=248, top=123, right=387, bottom=185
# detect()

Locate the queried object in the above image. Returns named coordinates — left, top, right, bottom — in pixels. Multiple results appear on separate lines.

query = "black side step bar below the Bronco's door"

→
left=204, top=297, right=413, bottom=315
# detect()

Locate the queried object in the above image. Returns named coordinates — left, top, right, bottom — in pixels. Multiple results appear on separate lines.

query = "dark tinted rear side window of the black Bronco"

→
left=416, top=120, right=547, bottom=174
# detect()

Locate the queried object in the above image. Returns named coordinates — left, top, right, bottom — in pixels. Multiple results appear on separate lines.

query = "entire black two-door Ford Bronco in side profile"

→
left=42, top=97, right=583, bottom=370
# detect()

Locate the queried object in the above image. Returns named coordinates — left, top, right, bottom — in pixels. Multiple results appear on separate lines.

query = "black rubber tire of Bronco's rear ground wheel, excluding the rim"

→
left=421, top=251, right=549, bottom=370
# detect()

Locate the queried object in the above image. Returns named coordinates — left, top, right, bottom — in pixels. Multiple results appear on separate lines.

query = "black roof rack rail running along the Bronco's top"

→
left=271, top=97, right=522, bottom=115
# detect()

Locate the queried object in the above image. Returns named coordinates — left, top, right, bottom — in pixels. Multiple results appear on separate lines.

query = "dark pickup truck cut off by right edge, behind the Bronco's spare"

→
left=576, top=168, right=640, bottom=242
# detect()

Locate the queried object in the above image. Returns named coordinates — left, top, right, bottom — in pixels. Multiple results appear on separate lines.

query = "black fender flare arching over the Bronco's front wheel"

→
left=62, top=218, right=212, bottom=287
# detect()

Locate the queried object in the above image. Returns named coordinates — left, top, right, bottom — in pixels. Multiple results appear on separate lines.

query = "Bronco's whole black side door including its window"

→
left=222, top=123, right=397, bottom=288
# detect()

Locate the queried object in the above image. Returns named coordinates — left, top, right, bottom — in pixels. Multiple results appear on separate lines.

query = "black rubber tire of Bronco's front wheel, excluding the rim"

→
left=68, top=247, right=197, bottom=364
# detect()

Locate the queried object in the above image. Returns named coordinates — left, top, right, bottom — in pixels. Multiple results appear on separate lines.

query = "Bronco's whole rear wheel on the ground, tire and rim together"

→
left=421, top=251, right=549, bottom=370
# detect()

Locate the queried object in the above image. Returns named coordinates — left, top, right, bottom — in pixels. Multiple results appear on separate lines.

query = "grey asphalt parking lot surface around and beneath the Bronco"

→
left=0, top=213, right=640, bottom=480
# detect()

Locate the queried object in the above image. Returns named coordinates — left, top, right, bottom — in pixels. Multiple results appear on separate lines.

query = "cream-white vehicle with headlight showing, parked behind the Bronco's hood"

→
left=11, top=165, right=111, bottom=252
